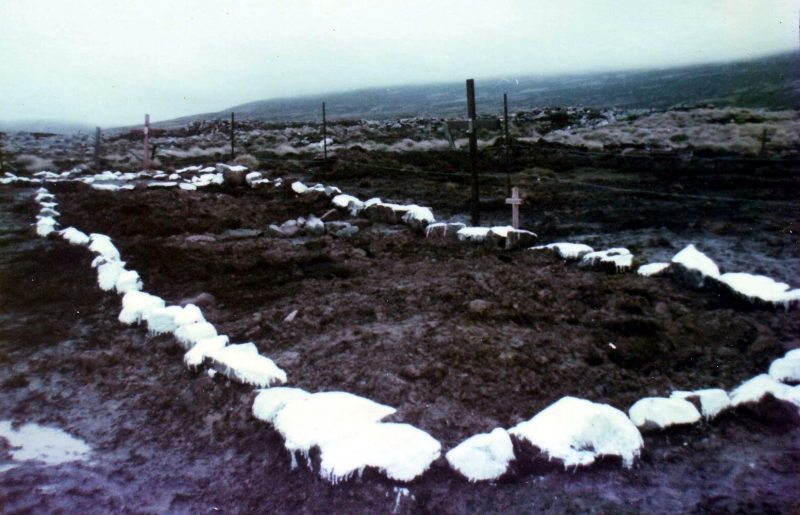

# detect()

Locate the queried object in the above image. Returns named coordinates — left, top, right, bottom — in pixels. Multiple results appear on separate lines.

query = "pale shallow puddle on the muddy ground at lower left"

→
left=0, top=420, right=91, bottom=473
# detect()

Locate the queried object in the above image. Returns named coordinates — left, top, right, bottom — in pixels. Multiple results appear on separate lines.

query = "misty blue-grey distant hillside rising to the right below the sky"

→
left=157, top=52, right=800, bottom=126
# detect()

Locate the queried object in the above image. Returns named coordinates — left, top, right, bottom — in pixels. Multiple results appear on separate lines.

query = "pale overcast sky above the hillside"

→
left=0, top=0, right=800, bottom=126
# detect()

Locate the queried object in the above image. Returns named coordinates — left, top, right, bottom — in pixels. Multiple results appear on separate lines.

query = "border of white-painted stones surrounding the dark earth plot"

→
left=12, top=169, right=800, bottom=483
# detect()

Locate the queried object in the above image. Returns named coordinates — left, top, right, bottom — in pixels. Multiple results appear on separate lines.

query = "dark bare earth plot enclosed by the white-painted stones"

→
left=47, top=179, right=798, bottom=450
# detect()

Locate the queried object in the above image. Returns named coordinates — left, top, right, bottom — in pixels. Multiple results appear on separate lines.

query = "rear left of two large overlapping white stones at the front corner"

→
left=273, top=392, right=396, bottom=456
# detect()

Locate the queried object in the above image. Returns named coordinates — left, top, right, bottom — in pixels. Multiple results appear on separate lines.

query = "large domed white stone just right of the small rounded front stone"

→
left=509, top=397, right=644, bottom=468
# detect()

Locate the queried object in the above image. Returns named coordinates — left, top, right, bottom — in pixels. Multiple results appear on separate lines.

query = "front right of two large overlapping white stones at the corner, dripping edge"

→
left=320, top=423, right=441, bottom=483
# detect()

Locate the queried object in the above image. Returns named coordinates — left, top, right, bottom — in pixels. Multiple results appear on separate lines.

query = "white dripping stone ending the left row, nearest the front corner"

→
left=206, top=342, right=286, bottom=388
